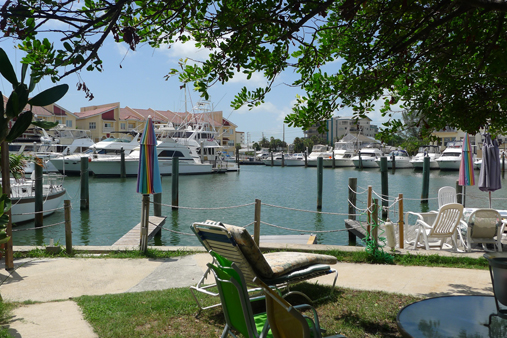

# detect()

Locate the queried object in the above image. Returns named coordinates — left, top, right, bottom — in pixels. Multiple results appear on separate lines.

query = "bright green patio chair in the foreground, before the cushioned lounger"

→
left=208, top=263, right=272, bottom=338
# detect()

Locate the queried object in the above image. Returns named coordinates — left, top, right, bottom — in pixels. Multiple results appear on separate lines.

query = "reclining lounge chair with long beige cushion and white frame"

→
left=191, top=221, right=338, bottom=309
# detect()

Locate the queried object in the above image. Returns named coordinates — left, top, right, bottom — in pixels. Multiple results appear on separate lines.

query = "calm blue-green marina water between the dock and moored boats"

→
left=14, top=166, right=507, bottom=246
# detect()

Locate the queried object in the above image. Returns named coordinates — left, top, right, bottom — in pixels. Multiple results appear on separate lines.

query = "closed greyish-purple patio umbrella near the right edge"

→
left=479, top=133, right=502, bottom=208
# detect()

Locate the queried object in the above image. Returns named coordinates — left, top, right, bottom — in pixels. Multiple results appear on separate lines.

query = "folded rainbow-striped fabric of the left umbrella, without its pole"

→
left=137, top=116, right=162, bottom=195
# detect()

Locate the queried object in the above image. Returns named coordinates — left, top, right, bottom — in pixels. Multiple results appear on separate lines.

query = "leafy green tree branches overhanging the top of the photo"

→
left=0, top=0, right=507, bottom=137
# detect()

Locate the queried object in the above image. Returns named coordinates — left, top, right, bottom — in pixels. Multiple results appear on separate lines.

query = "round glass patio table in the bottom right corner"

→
left=396, top=296, right=507, bottom=338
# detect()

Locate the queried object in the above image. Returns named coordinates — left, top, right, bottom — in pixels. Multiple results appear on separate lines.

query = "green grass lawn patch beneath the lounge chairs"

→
left=75, top=283, right=420, bottom=338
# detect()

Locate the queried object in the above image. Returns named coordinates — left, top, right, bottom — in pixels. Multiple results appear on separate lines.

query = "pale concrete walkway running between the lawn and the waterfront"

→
left=0, top=247, right=493, bottom=338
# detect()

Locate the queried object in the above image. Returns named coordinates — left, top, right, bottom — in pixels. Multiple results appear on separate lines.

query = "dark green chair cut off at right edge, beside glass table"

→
left=484, top=253, right=507, bottom=318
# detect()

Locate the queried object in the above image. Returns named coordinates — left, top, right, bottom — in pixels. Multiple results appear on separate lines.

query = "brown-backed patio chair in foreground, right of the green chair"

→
left=254, top=278, right=345, bottom=338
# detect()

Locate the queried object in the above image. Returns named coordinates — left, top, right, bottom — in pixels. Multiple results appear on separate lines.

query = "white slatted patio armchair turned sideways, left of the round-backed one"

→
left=414, top=203, right=466, bottom=251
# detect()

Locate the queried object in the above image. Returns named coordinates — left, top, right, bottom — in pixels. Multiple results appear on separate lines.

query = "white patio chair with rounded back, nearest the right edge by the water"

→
left=467, top=209, right=505, bottom=252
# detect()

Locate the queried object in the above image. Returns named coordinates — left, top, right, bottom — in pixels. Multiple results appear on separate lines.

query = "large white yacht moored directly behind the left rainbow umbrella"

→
left=88, top=137, right=213, bottom=177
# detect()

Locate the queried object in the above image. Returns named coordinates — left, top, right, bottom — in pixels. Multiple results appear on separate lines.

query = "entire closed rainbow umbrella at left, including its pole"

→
left=137, top=116, right=162, bottom=252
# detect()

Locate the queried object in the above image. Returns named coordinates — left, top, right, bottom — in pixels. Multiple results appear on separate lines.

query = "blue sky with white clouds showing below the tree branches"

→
left=0, top=34, right=390, bottom=143
